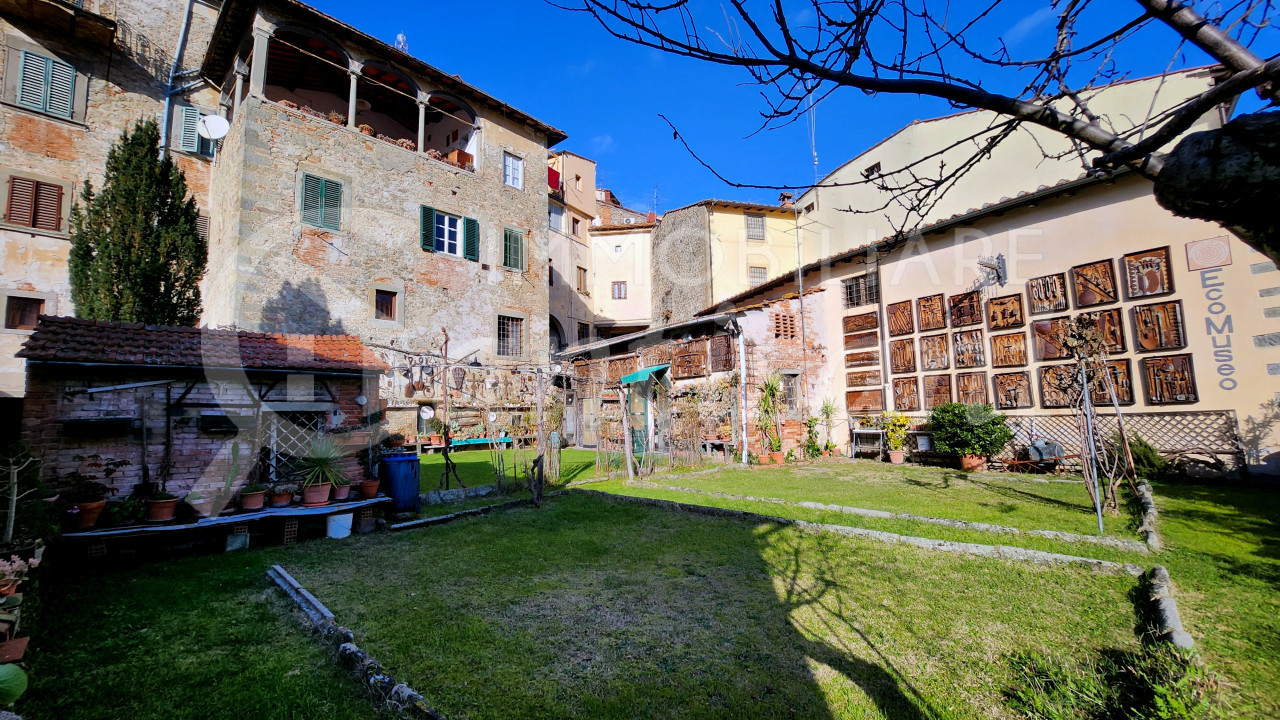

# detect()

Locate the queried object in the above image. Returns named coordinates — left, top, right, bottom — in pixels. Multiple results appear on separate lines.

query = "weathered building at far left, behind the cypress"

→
left=0, top=0, right=218, bottom=418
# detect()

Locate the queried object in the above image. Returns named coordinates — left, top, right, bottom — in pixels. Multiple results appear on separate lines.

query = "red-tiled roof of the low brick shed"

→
left=18, top=315, right=388, bottom=374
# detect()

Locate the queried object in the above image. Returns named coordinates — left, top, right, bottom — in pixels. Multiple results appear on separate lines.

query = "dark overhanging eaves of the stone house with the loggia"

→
left=200, top=0, right=568, bottom=147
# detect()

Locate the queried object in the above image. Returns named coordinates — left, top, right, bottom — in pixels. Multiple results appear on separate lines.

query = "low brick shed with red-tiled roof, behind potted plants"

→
left=18, top=316, right=388, bottom=500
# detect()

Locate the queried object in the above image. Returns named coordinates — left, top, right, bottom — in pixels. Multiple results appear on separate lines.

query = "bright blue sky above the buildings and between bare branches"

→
left=304, top=0, right=1280, bottom=211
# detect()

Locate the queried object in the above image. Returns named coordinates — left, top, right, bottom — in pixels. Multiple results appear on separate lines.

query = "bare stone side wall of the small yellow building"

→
left=649, top=205, right=710, bottom=325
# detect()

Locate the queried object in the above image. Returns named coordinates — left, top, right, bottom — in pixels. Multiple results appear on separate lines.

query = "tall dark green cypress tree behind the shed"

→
left=69, top=119, right=207, bottom=327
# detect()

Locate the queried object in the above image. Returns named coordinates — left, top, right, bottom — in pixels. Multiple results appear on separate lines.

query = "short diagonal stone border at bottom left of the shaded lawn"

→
left=266, top=565, right=445, bottom=720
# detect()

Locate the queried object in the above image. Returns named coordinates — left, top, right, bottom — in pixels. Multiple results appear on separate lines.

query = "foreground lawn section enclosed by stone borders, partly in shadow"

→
left=290, top=495, right=1137, bottom=720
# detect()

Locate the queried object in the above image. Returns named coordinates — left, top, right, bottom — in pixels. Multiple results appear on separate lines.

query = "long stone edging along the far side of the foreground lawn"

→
left=573, top=488, right=1143, bottom=577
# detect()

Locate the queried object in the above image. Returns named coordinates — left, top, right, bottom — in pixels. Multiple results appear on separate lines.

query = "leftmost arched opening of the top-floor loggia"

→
left=264, top=28, right=351, bottom=124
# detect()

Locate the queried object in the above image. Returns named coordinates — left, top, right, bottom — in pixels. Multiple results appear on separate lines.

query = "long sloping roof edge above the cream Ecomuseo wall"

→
left=694, top=168, right=1132, bottom=316
